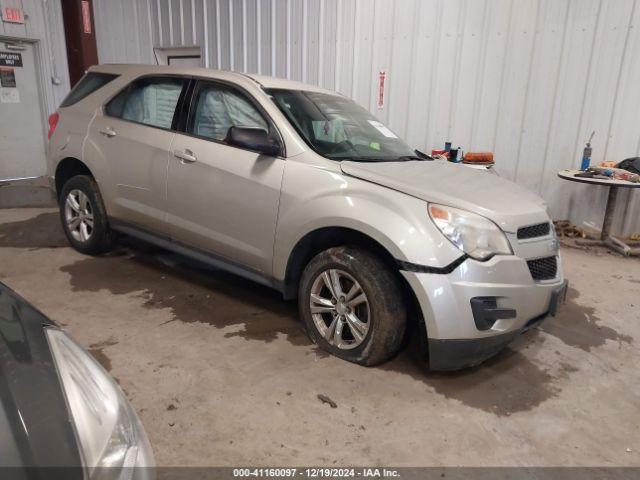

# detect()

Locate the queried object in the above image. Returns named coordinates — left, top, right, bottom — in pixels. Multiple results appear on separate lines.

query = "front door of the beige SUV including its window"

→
left=167, top=81, right=284, bottom=276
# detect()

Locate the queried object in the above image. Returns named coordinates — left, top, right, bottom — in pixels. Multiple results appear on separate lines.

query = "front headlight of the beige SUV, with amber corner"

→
left=429, top=203, right=513, bottom=260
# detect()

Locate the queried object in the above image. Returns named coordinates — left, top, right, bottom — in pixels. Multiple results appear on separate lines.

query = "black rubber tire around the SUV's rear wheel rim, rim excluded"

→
left=59, top=175, right=113, bottom=255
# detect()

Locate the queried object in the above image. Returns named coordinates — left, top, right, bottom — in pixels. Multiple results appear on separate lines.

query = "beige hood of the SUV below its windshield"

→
left=340, top=160, right=549, bottom=232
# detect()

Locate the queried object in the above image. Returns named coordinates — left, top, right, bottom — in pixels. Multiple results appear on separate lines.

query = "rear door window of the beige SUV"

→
left=105, top=77, right=185, bottom=129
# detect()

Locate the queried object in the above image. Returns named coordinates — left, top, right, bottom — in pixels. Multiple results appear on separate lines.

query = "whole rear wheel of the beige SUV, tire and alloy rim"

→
left=59, top=175, right=113, bottom=255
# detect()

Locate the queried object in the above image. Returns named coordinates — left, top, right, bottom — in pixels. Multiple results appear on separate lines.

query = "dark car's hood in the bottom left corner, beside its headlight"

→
left=0, top=283, right=82, bottom=472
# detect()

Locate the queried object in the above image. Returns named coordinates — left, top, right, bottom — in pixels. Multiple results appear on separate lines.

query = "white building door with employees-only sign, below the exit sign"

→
left=0, top=39, right=46, bottom=180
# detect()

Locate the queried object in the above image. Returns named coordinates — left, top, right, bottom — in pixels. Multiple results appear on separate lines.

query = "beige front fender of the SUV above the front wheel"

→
left=273, top=161, right=461, bottom=280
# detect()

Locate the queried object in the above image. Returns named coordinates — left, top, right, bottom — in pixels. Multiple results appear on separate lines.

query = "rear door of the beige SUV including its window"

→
left=87, top=76, right=188, bottom=233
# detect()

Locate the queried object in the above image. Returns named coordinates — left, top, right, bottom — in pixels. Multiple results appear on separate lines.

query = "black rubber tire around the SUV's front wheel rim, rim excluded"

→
left=298, top=247, right=407, bottom=366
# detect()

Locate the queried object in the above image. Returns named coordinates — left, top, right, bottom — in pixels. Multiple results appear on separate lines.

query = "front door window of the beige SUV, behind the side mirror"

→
left=187, top=84, right=269, bottom=141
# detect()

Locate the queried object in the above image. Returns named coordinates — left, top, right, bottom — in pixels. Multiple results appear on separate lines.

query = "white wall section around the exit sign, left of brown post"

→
left=0, top=0, right=69, bottom=115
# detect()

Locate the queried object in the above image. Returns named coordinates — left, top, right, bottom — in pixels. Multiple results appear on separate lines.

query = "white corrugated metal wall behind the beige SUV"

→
left=93, top=0, right=640, bottom=234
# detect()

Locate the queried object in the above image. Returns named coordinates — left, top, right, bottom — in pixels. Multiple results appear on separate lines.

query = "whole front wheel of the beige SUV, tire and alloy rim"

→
left=298, top=247, right=407, bottom=366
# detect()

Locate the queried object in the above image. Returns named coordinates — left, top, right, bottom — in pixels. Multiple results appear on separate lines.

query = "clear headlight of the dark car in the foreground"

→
left=46, top=328, right=155, bottom=479
